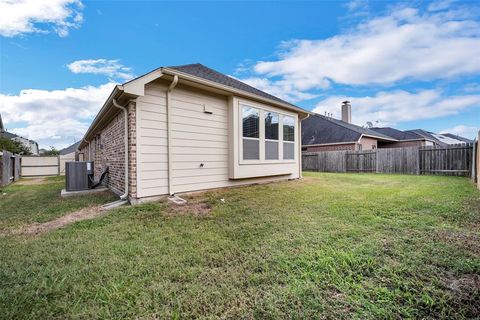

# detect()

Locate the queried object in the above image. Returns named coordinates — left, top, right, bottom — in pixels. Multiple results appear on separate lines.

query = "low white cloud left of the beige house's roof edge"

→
left=0, top=83, right=114, bottom=148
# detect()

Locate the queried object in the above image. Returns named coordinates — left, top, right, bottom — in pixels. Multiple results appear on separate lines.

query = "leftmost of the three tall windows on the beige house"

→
left=242, top=106, right=260, bottom=160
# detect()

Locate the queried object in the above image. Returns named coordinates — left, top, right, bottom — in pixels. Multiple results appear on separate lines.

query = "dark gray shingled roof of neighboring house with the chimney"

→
left=302, top=114, right=396, bottom=145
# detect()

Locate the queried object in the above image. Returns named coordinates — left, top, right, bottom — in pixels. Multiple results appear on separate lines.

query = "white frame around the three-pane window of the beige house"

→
left=236, top=99, right=299, bottom=165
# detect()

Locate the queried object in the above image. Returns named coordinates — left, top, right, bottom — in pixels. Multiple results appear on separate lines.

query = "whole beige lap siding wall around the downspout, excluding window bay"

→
left=137, top=82, right=299, bottom=198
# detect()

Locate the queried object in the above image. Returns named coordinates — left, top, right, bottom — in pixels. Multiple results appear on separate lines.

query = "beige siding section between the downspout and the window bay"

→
left=171, top=87, right=229, bottom=192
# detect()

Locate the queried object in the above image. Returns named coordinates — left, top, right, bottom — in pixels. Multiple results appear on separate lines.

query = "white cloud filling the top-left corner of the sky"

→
left=0, top=0, right=83, bottom=37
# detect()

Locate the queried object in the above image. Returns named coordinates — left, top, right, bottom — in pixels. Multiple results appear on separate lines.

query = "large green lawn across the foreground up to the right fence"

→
left=0, top=173, right=480, bottom=319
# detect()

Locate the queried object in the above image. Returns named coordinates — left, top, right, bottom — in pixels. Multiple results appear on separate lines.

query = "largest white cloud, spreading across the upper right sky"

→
left=253, top=7, right=480, bottom=91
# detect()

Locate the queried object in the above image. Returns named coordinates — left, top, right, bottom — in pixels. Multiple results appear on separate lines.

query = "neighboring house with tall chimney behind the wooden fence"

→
left=302, top=101, right=397, bottom=152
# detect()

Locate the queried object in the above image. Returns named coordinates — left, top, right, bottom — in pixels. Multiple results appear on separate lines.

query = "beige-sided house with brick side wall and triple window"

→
left=78, top=64, right=308, bottom=203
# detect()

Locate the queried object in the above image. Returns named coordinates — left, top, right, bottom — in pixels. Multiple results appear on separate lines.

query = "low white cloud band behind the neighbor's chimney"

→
left=313, top=90, right=480, bottom=126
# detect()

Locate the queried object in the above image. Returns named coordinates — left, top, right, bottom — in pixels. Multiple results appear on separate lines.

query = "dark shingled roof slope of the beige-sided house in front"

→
left=166, top=63, right=298, bottom=108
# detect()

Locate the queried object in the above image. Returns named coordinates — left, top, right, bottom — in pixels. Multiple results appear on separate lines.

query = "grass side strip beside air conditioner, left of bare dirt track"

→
left=0, top=177, right=115, bottom=233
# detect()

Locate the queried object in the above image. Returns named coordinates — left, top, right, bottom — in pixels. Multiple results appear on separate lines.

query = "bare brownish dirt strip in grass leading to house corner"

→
left=6, top=206, right=107, bottom=235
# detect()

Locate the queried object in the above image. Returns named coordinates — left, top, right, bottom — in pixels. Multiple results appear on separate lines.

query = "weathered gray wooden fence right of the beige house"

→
left=302, top=143, right=474, bottom=176
